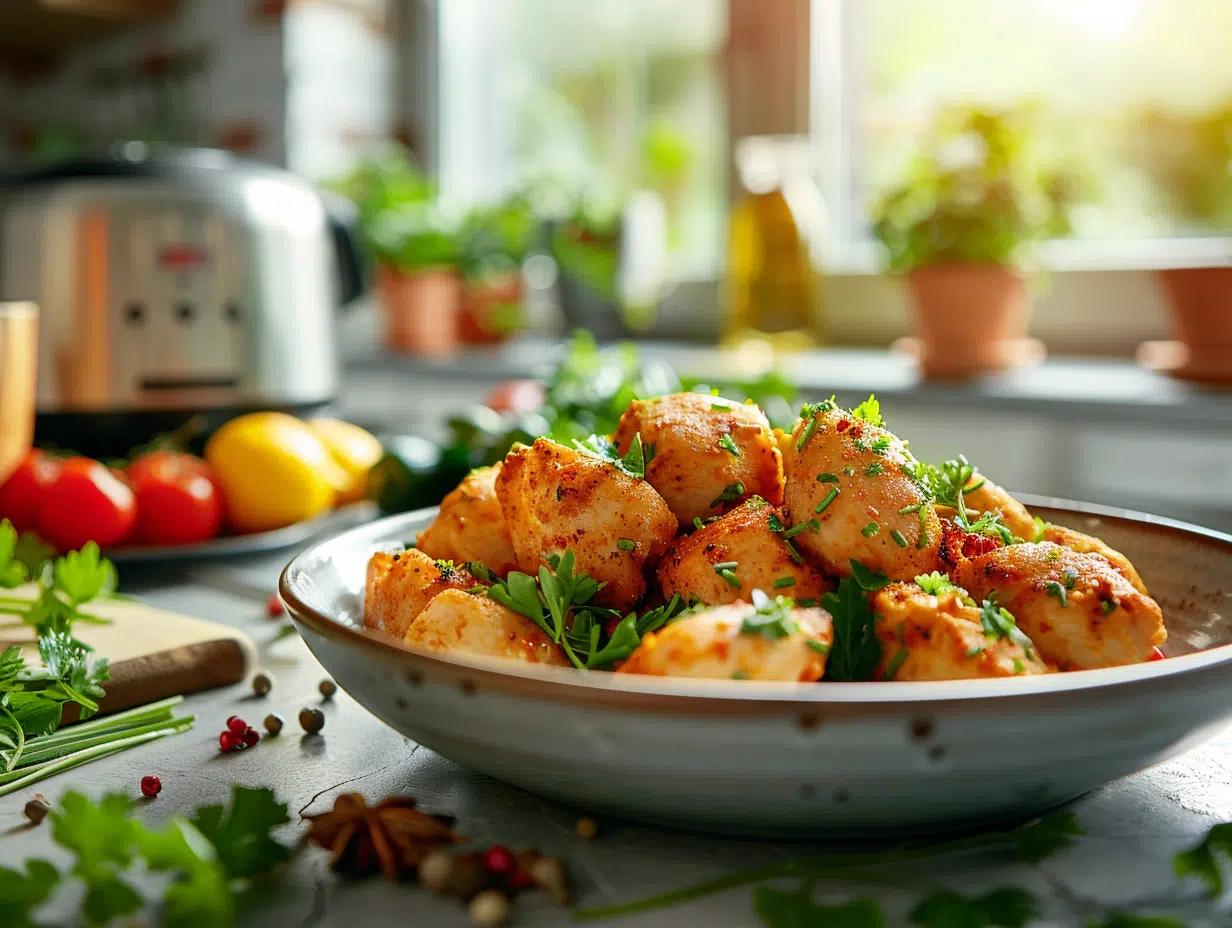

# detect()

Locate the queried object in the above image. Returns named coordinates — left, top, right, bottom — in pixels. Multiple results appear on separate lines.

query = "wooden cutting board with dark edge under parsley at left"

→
left=0, top=587, right=256, bottom=714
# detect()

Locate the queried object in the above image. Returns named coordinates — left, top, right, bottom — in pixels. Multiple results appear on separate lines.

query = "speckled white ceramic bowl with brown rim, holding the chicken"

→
left=281, top=499, right=1232, bottom=836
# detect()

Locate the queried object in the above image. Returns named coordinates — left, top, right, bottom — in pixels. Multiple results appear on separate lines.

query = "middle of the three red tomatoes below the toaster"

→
left=37, top=457, right=137, bottom=551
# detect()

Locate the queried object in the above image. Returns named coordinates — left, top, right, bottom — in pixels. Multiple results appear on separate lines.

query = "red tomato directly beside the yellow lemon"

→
left=128, top=451, right=223, bottom=545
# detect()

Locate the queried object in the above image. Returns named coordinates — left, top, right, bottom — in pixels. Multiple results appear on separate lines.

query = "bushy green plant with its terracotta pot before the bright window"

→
left=873, top=108, right=1078, bottom=376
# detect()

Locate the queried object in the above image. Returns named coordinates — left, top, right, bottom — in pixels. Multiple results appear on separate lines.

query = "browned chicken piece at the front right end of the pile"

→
left=954, top=542, right=1168, bottom=670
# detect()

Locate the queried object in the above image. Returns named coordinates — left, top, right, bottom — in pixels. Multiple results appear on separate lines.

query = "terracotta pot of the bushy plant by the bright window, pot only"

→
left=907, top=264, right=1031, bottom=377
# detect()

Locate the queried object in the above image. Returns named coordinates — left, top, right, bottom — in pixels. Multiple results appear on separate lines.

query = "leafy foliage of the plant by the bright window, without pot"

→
left=872, top=108, right=1087, bottom=272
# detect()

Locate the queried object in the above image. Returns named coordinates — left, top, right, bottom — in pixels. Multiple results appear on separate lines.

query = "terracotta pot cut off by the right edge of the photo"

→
left=1158, top=267, right=1232, bottom=382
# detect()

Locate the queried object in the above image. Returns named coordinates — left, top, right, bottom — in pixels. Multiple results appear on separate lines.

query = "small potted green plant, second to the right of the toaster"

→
left=460, top=195, right=537, bottom=344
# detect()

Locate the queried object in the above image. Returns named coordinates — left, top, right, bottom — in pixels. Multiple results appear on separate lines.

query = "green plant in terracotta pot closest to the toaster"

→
left=336, top=150, right=462, bottom=354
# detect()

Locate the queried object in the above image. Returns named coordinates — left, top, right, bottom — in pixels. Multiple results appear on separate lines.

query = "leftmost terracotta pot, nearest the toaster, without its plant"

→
left=377, top=266, right=462, bottom=355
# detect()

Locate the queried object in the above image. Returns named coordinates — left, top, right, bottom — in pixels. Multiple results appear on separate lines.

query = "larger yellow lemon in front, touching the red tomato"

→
left=206, top=413, right=346, bottom=532
